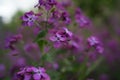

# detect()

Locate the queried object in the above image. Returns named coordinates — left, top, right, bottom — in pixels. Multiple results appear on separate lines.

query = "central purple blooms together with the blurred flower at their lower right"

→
left=49, top=27, right=82, bottom=50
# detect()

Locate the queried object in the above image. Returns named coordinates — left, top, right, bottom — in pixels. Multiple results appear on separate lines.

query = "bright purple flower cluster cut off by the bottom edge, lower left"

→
left=17, top=67, right=50, bottom=80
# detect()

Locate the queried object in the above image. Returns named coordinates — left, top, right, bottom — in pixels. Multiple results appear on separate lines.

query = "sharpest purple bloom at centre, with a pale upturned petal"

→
left=50, top=28, right=73, bottom=47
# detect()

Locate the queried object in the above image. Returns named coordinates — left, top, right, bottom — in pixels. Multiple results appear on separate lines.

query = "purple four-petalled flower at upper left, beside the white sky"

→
left=21, top=11, right=41, bottom=26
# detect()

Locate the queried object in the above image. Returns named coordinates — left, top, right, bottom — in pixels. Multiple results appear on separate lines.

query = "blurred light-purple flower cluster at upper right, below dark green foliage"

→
left=75, top=8, right=90, bottom=27
